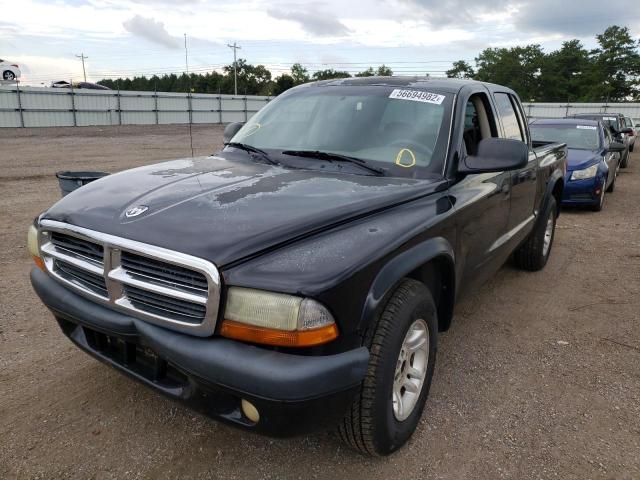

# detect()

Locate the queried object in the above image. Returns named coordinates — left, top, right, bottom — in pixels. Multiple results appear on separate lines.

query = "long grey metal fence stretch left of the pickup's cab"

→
left=0, top=85, right=271, bottom=127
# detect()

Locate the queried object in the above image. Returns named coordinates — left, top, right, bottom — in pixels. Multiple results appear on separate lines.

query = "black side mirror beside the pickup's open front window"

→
left=458, top=138, right=529, bottom=174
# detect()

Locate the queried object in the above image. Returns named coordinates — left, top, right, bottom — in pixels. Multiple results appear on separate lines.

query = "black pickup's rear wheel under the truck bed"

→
left=513, top=195, right=558, bottom=272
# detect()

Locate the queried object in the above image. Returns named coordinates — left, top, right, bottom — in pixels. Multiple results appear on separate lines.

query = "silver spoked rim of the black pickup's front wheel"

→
left=393, top=318, right=429, bottom=422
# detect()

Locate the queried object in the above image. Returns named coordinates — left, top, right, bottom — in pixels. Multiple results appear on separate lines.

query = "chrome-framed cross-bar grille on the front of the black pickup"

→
left=40, top=220, right=220, bottom=336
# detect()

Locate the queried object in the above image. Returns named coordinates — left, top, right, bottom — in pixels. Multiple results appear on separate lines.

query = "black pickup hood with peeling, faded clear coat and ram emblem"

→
left=42, top=156, right=446, bottom=267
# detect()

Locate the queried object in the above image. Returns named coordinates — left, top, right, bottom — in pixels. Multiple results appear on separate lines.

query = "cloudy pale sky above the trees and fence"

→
left=0, top=0, right=640, bottom=85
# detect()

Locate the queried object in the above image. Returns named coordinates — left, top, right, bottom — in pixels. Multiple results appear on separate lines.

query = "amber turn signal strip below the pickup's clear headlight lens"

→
left=220, top=320, right=338, bottom=347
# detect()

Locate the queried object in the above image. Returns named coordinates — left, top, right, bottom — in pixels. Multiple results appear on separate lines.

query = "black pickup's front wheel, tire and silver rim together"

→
left=338, top=279, right=438, bottom=456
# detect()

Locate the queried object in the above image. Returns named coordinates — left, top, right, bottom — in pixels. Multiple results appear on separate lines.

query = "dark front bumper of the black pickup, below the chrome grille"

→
left=31, top=268, right=369, bottom=437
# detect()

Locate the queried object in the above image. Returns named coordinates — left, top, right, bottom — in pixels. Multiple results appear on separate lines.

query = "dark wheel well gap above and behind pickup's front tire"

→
left=407, top=256, right=455, bottom=332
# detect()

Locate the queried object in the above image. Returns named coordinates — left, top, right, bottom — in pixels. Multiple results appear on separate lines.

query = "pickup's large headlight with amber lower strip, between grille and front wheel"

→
left=220, top=287, right=338, bottom=347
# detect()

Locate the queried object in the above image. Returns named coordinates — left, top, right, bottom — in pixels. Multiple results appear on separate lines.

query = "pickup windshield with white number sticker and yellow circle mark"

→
left=232, top=85, right=453, bottom=177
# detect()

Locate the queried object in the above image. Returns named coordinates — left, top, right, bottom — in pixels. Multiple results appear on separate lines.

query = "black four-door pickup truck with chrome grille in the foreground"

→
left=28, top=77, right=566, bottom=455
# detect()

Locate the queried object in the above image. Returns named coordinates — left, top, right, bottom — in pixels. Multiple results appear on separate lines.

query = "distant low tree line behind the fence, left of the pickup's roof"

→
left=97, top=62, right=393, bottom=96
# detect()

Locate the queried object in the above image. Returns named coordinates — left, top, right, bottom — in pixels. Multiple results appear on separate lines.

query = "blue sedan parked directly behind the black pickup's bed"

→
left=529, top=118, right=625, bottom=211
